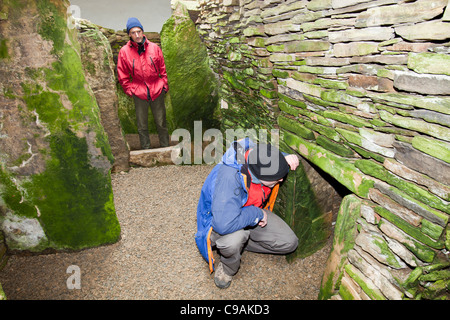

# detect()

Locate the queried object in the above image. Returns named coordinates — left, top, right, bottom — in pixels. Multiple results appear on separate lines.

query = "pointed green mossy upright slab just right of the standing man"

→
left=161, top=3, right=219, bottom=130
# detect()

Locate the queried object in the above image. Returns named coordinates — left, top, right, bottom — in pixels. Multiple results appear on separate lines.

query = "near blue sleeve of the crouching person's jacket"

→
left=211, top=166, right=264, bottom=235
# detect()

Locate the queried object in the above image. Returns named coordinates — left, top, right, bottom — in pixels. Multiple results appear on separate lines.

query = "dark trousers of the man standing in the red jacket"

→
left=133, top=91, right=169, bottom=149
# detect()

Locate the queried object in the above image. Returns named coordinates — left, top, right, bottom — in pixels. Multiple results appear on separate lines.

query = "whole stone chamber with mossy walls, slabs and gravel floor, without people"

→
left=0, top=0, right=450, bottom=300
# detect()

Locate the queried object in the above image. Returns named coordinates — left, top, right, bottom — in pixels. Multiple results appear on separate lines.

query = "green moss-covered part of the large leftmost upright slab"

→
left=0, top=0, right=120, bottom=250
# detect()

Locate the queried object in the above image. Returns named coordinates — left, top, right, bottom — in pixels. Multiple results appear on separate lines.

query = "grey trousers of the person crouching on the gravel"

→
left=211, top=211, right=298, bottom=276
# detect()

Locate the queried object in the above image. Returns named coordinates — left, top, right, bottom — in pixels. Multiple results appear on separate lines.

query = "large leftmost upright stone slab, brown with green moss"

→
left=0, top=0, right=120, bottom=251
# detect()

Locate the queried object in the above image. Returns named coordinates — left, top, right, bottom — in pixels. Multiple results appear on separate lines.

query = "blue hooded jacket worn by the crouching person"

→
left=195, top=138, right=274, bottom=272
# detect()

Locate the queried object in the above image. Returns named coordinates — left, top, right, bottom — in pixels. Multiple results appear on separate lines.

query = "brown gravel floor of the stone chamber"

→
left=0, top=165, right=331, bottom=300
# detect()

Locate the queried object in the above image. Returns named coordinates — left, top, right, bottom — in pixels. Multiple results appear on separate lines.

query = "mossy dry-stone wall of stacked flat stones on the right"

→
left=196, top=0, right=450, bottom=299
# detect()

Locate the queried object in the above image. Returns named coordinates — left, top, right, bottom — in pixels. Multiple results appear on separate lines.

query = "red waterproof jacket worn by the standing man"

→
left=117, top=38, right=169, bottom=101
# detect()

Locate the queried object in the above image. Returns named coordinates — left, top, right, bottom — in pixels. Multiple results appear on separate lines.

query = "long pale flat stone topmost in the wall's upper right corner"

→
left=355, top=0, right=447, bottom=28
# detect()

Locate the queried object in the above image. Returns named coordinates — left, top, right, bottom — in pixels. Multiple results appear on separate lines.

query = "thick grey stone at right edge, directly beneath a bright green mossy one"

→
left=394, top=71, right=450, bottom=95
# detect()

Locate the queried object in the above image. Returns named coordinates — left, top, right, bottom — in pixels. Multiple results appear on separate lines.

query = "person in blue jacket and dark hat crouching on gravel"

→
left=195, top=138, right=299, bottom=288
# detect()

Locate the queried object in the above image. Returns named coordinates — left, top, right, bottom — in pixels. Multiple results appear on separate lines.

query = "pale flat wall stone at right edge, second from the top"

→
left=395, top=20, right=450, bottom=41
